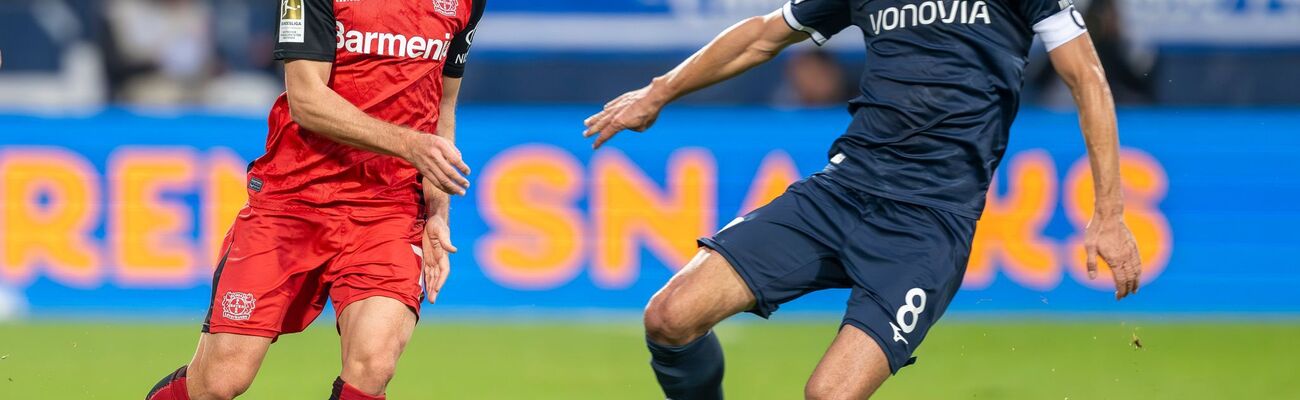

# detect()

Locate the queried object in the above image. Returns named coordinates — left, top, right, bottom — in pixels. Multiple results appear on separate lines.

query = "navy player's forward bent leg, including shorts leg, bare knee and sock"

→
left=645, top=175, right=861, bottom=400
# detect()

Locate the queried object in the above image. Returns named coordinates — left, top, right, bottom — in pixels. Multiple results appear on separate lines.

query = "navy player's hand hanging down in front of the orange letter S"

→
left=1083, top=216, right=1141, bottom=300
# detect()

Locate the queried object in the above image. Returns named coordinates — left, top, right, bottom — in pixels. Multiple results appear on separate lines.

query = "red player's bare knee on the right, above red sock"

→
left=335, top=296, right=416, bottom=399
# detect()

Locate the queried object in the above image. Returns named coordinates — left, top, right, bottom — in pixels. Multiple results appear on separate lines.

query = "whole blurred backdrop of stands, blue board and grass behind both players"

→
left=0, top=0, right=1300, bottom=399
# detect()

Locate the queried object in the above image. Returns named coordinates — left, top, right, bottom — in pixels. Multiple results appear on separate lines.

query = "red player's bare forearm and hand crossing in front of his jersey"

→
left=285, top=60, right=469, bottom=195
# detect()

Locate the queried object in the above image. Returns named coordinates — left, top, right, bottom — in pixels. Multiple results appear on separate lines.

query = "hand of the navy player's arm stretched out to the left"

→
left=582, top=84, right=664, bottom=148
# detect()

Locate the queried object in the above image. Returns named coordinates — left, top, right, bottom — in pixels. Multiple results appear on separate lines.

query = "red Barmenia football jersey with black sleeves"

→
left=248, top=0, right=486, bottom=212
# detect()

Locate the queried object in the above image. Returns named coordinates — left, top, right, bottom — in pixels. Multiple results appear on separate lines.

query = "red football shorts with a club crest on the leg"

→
left=203, top=206, right=424, bottom=338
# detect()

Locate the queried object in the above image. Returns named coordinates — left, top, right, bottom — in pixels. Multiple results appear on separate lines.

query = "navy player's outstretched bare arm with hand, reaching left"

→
left=582, top=10, right=809, bottom=148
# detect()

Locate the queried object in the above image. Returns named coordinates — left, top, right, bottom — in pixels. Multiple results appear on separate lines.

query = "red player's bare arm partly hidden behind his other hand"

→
left=420, top=77, right=462, bottom=303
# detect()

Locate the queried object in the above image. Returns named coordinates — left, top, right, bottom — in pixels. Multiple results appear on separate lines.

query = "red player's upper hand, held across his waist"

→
left=402, top=132, right=469, bottom=195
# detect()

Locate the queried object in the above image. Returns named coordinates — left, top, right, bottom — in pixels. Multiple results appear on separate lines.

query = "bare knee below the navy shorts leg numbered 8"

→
left=803, top=323, right=889, bottom=400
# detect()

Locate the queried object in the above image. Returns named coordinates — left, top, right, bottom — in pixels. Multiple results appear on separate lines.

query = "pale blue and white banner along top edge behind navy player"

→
left=476, top=0, right=1300, bottom=52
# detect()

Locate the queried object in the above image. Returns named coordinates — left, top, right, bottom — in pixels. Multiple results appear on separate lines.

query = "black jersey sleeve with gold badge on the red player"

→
left=274, top=0, right=338, bottom=62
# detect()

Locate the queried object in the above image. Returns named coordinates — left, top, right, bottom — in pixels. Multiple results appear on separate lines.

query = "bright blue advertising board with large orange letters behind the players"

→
left=0, top=106, right=1300, bottom=317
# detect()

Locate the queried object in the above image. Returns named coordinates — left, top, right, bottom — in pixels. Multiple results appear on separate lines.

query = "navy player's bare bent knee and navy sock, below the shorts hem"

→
left=645, top=249, right=754, bottom=400
